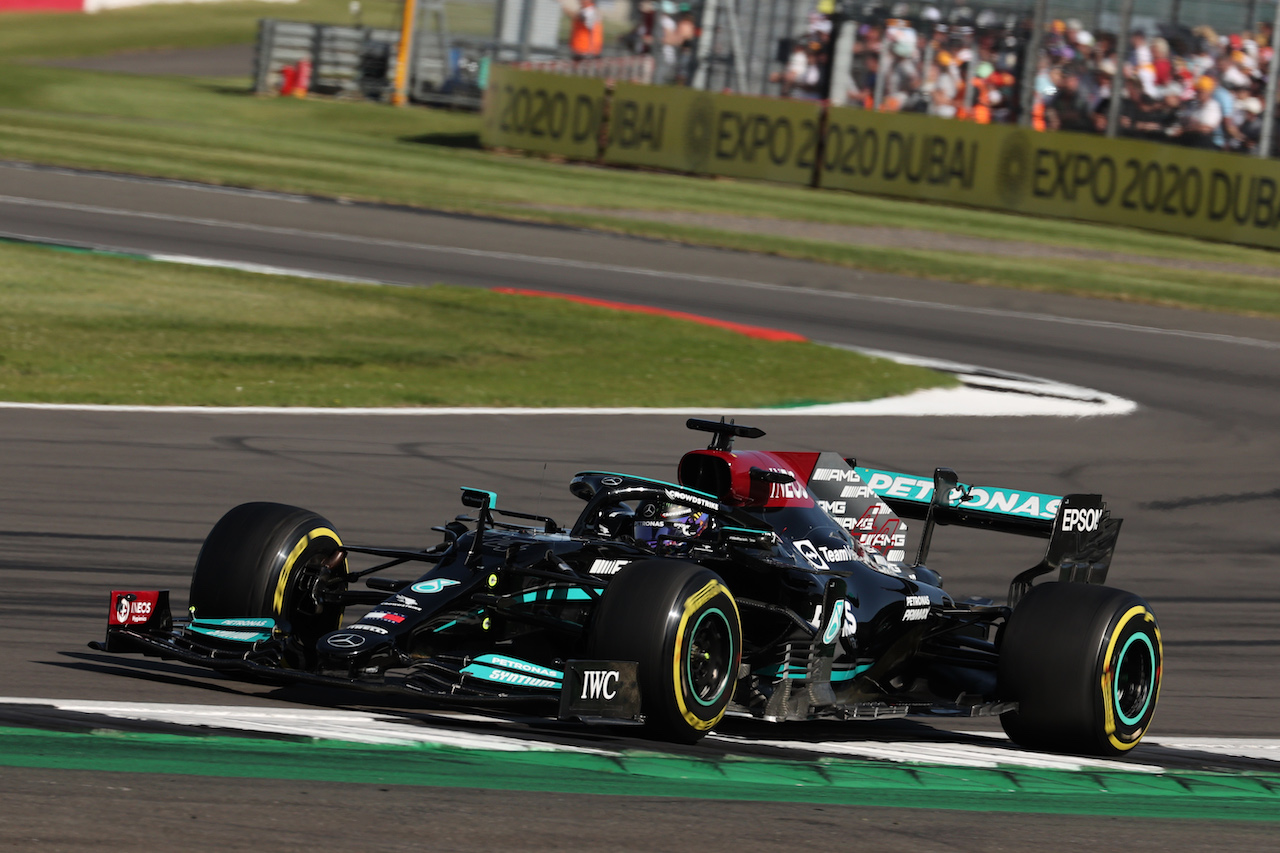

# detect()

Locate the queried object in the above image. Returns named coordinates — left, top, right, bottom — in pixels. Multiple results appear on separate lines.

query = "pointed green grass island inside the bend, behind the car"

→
left=0, top=243, right=954, bottom=407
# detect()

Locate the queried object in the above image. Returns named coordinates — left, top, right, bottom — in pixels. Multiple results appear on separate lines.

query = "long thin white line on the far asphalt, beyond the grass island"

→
left=0, top=195, right=1280, bottom=350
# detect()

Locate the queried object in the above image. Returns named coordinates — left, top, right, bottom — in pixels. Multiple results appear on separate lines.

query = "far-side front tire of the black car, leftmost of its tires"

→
left=189, top=503, right=347, bottom=665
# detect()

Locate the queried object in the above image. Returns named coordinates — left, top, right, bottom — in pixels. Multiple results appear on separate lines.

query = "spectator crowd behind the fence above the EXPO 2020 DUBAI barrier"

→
left=777, top=5, right=1280, bottom=155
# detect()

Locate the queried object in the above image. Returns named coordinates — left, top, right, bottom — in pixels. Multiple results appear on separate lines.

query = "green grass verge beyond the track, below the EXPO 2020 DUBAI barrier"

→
left=0, top=0, right=1280, bottom=316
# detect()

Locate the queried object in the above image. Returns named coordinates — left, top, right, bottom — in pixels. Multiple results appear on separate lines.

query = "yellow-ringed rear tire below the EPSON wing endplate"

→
left=1000, top=583, right=1164, bottom=756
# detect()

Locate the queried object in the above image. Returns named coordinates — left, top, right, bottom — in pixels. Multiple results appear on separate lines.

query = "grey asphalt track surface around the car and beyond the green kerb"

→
left=0, top=159, right=1280, bottom=850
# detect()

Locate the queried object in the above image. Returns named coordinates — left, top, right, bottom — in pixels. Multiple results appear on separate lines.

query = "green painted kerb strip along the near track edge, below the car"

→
left=0, top=727, right=1280, bottom=821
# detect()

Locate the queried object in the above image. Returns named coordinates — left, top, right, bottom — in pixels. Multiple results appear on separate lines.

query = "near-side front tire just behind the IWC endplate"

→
left=591, top=560, right=742, bottom=743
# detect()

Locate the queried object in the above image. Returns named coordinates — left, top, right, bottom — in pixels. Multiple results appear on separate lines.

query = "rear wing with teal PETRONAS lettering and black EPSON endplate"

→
left=854, top=466, right=1123, bottom=606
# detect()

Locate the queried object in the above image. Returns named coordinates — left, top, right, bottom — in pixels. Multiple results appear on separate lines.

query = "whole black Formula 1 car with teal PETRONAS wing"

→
left=91, top=419, right=1162, bottom=754
